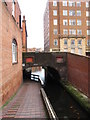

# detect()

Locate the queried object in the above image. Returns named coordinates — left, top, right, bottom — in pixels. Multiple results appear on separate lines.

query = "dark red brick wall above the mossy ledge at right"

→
left=67, top=54, right=90, bottom=97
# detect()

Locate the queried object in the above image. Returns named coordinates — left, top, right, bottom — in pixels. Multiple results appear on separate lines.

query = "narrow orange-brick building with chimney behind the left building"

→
left=22, top=16, right=27, bottom=52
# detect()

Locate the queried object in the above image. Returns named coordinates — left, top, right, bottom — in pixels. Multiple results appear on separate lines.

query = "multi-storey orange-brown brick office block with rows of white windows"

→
left=44, top=0, right=90, bottom=55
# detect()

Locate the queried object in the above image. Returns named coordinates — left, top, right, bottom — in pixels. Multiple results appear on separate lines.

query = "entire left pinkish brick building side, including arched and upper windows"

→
left=0, top=0, right=22, bottom=106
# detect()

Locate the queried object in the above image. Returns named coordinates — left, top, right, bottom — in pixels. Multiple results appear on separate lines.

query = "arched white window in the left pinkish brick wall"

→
left=12, top=39, right=17, bottom=63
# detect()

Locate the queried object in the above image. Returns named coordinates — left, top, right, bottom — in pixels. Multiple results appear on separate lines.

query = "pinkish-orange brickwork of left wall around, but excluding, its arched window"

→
left=0, top=3, right=22, bottom=104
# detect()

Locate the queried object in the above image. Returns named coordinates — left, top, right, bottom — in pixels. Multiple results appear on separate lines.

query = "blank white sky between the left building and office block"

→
left=18, top=0, right=47, bottom=48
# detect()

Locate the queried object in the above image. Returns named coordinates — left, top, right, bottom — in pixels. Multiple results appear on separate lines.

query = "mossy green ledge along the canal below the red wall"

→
left=60, top=81, right=90, bottom=113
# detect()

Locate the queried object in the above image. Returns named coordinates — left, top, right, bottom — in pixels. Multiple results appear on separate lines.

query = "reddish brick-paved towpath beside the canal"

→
left=2, top=81, right=48, bottom=118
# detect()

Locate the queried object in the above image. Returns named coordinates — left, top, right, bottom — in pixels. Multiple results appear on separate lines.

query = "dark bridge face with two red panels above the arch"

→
left=22, top=52, right=67, bottom=79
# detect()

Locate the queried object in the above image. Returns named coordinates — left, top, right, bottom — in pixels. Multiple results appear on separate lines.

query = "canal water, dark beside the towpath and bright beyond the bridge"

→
left=31, top=70, right=90, bottom=120
